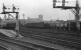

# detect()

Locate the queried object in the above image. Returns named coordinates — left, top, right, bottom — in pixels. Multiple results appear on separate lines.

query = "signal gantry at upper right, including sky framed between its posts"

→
left=53, top=0, right=80, bottom=21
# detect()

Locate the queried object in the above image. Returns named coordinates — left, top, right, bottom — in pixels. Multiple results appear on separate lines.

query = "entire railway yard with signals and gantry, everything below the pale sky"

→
left=0, top=0, right=81, bottom=50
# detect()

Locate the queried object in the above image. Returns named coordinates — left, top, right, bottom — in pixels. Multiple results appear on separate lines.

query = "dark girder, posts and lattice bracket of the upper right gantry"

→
left=53, top=0, right=80, bottom=21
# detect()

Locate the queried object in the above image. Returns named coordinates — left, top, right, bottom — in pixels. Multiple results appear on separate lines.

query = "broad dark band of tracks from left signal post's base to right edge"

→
left=20, top=29, right=81, bottom=48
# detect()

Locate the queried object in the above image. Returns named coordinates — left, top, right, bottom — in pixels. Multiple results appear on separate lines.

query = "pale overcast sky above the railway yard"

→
left=0, top=0, right=81, bottom=20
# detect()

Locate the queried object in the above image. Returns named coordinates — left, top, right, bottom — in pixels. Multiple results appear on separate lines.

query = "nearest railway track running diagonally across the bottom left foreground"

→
left=0, top=38, right=56, bottom=50
